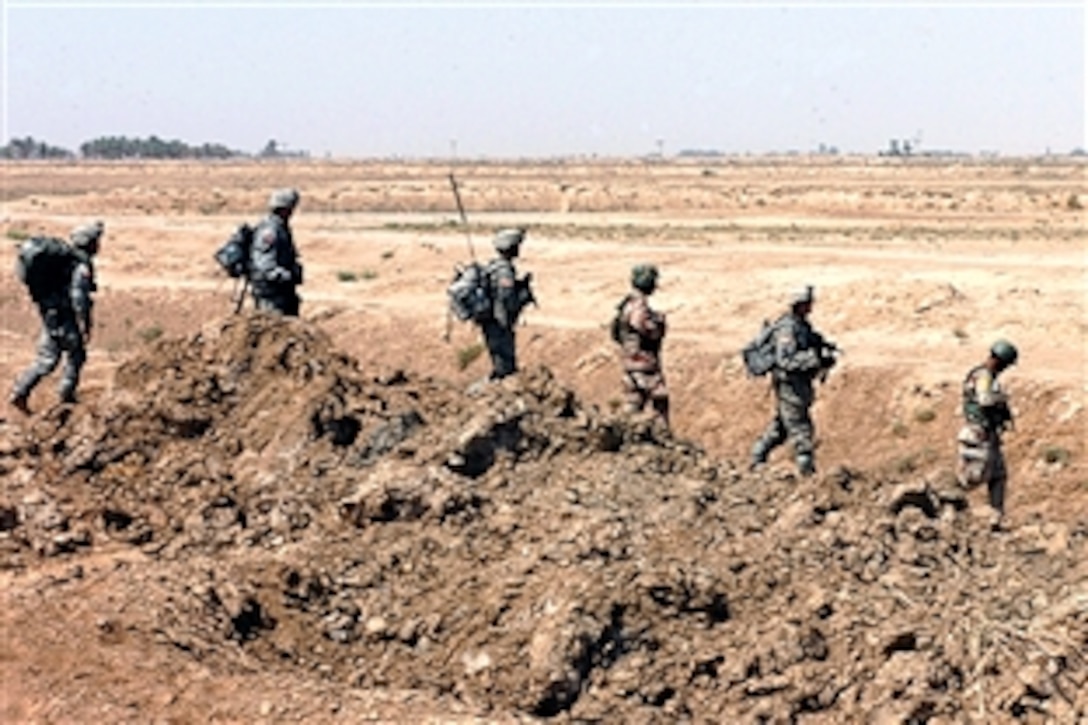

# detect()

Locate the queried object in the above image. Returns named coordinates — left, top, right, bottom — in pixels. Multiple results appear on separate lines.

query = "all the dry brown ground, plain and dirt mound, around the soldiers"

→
left=0, top=157, right=1088, bottom=723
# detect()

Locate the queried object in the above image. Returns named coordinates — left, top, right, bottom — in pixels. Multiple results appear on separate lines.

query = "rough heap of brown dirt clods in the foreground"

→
left=0, top=315, right=1088, bottom=723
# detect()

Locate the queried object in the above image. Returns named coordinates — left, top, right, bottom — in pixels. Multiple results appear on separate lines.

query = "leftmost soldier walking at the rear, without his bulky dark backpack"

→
left=11, top=221, right=106, bottom=414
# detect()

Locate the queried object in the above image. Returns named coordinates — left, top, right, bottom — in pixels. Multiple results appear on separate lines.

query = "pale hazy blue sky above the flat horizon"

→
left=0, top=0, right=1088, bottom=157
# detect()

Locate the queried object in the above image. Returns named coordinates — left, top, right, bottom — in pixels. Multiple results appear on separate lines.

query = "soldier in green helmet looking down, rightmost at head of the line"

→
left=956, top=340, right=1018, bottom=523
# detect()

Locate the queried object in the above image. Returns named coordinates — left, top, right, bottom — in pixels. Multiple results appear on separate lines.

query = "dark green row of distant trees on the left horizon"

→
left=0, top=135, right=309, bottom=159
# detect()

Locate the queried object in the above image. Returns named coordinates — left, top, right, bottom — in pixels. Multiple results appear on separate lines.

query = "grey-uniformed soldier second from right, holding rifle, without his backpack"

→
left=751, top=286, right=837, bottom=476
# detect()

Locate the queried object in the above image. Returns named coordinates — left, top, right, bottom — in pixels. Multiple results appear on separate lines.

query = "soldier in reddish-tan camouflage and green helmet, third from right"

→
left=617, top=265, right=669, bottom=428
